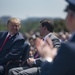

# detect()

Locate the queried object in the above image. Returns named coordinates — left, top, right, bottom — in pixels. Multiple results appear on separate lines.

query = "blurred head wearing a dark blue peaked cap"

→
left=66, top=0, right=75, bottom=32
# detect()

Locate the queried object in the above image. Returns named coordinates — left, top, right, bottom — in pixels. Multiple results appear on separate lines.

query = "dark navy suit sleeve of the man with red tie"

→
left=0, top=39, right=24, bottom=63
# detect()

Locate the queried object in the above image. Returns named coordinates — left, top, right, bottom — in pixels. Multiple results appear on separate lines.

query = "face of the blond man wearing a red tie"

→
left=7, top=21, right=20, bottom=35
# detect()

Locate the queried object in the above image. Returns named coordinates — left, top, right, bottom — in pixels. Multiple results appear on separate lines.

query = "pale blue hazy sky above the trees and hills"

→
left=0, top=0, right=67, bottom=19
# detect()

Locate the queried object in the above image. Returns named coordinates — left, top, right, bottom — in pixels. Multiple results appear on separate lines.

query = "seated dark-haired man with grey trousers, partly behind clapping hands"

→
left=9, top=20, right=60, bottom=75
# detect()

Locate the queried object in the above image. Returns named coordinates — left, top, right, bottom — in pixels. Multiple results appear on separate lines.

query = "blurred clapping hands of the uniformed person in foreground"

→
left=35, top=38, right=57, bottom=59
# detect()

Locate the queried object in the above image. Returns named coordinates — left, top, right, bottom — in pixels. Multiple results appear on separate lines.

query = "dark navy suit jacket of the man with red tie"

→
left=0, top=31, right=24, bottom=65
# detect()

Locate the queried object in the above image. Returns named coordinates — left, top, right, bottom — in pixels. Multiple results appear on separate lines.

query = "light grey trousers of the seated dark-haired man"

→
left=8, top=67, right=39, bottom=75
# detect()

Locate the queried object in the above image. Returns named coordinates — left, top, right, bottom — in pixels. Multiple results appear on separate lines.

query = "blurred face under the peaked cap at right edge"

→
left=66, top=10, right=75, bottom=32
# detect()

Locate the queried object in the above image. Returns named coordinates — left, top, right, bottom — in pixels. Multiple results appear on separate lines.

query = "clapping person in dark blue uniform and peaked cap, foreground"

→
left=36, top=0, right=75, bottom=75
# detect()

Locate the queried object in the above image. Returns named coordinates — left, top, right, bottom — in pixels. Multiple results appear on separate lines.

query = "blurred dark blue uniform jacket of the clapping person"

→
left=41, top=35, right=75, bottom=75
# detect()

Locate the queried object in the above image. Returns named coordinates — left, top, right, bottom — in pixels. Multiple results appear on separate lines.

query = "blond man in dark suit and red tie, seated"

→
left=0, top=18, right=25, bottom=75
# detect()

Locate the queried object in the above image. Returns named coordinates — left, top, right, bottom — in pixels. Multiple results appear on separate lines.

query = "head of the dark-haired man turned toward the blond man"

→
left=40, top=19, right=54, bottom=36
